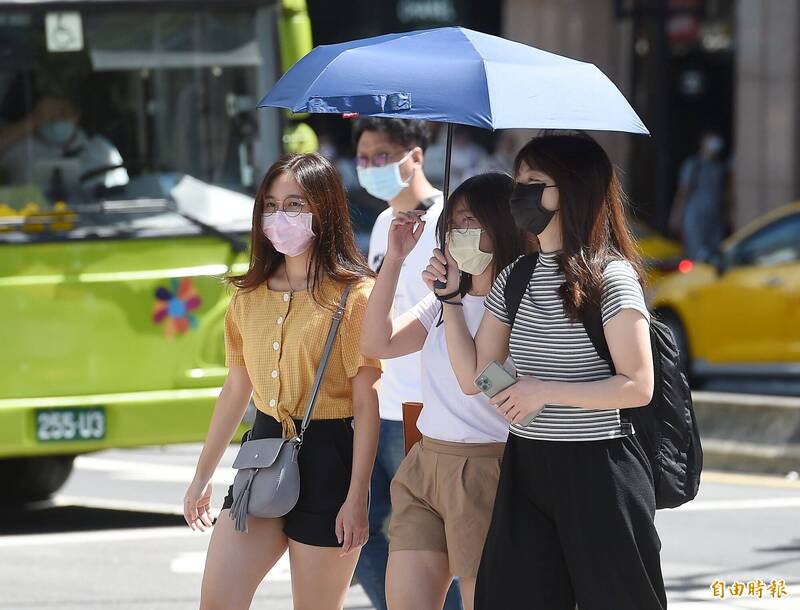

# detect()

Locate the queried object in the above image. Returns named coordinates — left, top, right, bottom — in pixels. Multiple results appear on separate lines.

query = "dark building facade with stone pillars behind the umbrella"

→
left=501, top=0, right=800, bottom=229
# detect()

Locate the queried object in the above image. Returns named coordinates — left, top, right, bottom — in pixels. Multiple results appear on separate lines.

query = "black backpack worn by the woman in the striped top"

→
left=504, top=253, right=703, bottom=508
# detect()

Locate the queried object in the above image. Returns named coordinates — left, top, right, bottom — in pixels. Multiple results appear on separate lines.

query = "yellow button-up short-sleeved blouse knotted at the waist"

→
left=220, top=279, right=381, bottom=438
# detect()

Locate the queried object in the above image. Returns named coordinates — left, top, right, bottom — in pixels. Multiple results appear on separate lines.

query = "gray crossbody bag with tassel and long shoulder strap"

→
left=225, top=286, right=350, bottom=532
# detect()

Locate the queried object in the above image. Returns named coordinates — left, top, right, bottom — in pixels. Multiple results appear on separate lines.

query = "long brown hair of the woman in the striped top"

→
left=514, top=134, right=644, bottom=320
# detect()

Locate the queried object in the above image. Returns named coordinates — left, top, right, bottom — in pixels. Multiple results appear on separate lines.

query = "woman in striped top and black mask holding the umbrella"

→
left=423, top=136, right=666, bottom=610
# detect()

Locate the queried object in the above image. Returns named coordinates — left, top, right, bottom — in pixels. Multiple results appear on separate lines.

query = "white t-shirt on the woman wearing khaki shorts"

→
left=411, top=294, right=514, bottom=443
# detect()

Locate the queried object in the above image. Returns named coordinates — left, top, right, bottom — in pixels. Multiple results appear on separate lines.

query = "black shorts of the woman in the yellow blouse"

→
left=222, top=411, right=353, bottom=547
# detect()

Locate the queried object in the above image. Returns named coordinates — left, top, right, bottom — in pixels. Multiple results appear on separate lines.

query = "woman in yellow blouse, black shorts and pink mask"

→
left=184, top=154, right=380, bottom=610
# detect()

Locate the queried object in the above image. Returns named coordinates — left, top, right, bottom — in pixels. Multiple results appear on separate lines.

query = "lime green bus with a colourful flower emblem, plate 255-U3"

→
left=0, top=0, right=314, bottom=501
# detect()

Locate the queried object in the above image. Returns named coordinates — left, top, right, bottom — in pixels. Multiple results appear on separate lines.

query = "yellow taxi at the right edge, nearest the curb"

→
left=650, top=201, right=800, bottom=380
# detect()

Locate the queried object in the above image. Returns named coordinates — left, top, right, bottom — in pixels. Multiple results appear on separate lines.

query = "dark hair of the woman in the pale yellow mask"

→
left=436, top=172, right=527, bottom=295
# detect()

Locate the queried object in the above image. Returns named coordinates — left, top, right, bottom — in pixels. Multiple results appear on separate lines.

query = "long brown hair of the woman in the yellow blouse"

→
left=228, top=153, right=375, bottom=309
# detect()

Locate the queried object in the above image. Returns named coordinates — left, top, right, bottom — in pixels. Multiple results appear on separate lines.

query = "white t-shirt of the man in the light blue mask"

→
left=369, top=193, right=442, bottom=421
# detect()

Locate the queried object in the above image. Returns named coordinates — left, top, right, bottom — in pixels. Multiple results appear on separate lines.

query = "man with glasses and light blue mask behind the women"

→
left=353, top=117, right=461, bottom=610
